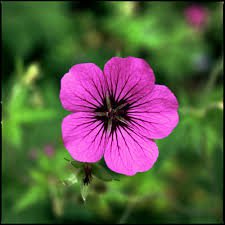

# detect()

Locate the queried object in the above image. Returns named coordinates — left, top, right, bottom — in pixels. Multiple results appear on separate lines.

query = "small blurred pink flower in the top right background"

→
left=185, top=5, right=208, bottom=29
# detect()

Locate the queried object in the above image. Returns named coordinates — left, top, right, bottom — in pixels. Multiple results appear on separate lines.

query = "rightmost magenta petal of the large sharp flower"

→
left=128, top=85, right=179, bottom=139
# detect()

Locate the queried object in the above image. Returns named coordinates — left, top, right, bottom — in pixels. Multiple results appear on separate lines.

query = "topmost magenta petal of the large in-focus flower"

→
left=104, top=57, right=155, bottom=101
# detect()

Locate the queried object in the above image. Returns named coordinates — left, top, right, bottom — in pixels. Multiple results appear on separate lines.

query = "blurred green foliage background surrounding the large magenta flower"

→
left=2, top=1, right=223, bottom=223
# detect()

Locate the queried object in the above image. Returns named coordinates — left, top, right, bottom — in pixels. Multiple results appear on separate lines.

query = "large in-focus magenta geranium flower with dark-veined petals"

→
left=60, top=57, right=179, bottom=176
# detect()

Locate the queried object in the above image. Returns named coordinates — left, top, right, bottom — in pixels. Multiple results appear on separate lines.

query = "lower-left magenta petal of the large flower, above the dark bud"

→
left=62, top=112, right=105, bottom=162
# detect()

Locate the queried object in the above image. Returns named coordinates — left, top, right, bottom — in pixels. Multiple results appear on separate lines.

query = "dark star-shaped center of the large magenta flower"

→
left=95, top=96, right=130, bottom=133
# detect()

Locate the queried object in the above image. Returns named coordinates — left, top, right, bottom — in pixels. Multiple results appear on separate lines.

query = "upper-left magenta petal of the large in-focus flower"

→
left=60, top=63, right=105, bottom=112
